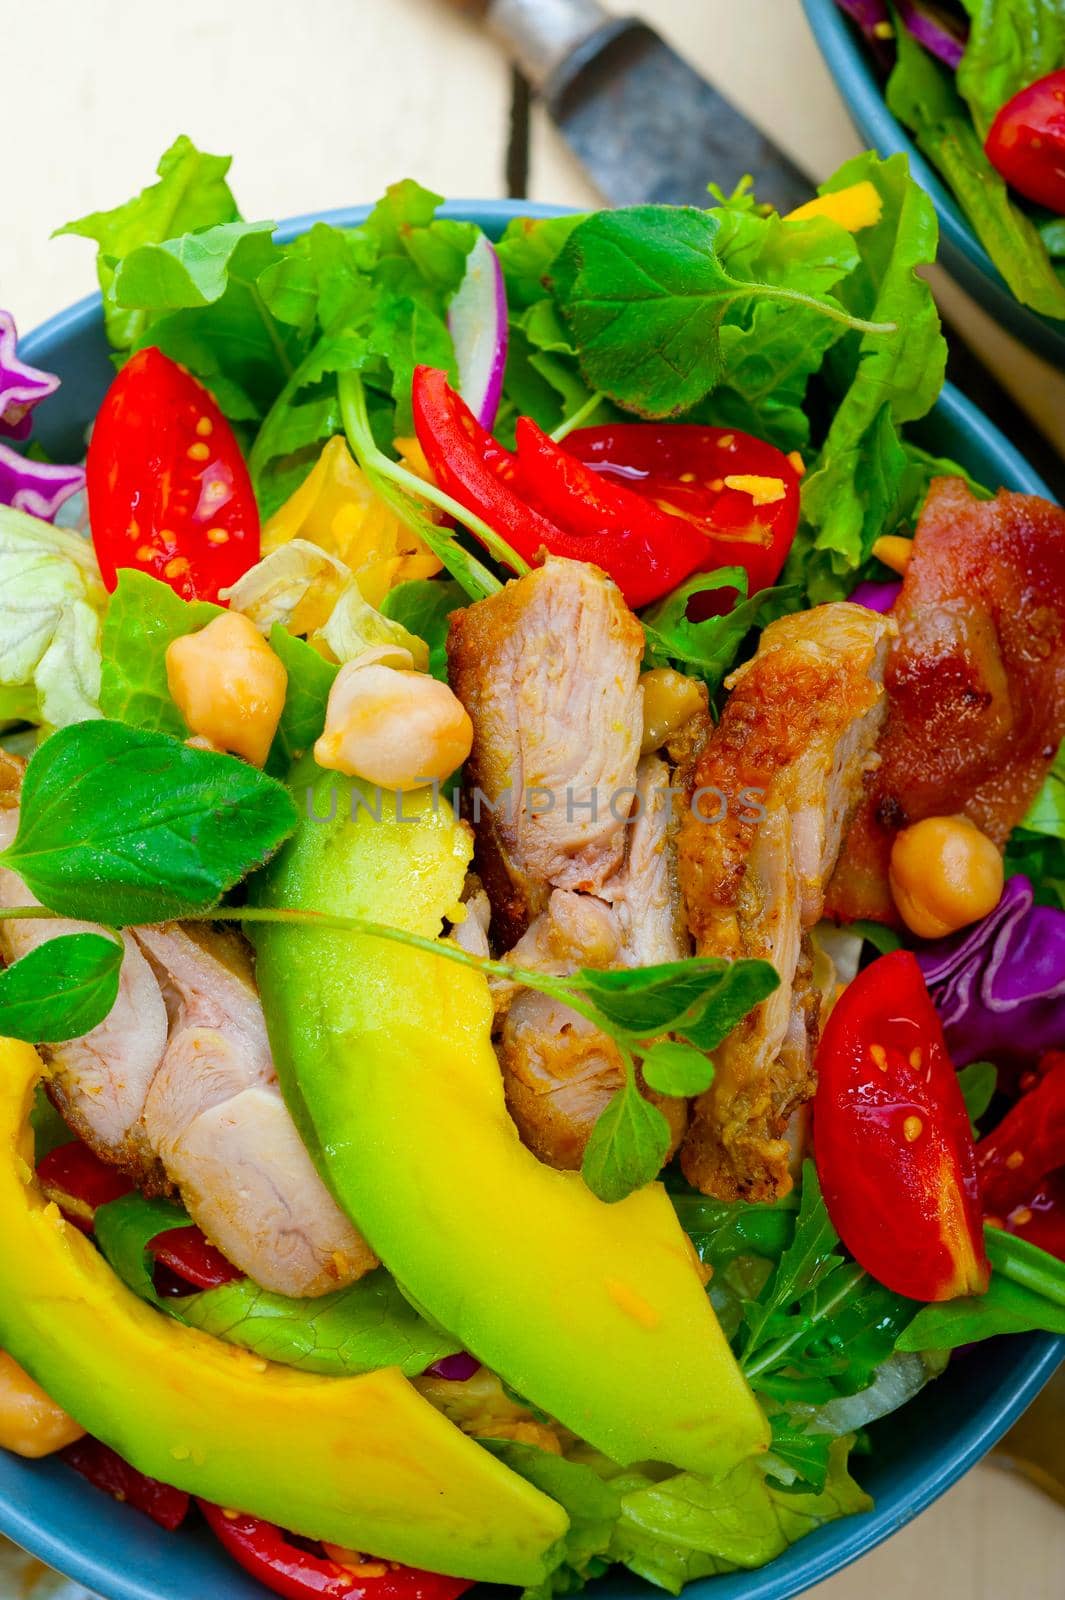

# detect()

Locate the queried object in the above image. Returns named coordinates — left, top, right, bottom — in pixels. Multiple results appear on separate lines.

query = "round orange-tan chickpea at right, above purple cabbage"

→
left=889, top=816, right=1004, bottom=939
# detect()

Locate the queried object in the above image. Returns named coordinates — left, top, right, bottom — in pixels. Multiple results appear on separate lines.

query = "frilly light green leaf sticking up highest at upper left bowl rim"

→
left=56, top=134, right=238, bottom=350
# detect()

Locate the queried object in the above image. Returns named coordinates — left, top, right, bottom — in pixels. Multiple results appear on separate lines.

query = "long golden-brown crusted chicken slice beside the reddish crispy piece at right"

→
left=678, top=603, right=894, bottom=1200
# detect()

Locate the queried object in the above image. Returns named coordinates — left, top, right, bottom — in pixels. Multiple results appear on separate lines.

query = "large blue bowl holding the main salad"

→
left=0, top=202, right=1065, bottom=1600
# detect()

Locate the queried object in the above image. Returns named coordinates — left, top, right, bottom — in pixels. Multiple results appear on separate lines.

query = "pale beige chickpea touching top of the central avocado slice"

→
left=315, top=659, right=473, bottom=790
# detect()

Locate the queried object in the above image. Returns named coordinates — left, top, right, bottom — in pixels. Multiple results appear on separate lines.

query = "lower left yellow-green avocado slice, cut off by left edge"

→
left=0, top=1038, right=568, bottom=1584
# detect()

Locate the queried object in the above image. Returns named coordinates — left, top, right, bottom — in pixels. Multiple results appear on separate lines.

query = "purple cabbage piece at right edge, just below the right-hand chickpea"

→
left=918, top=874, right=1065, bottom=1067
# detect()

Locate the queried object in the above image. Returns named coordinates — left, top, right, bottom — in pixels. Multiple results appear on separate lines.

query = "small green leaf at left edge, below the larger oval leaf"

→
left=0, top=933, right=123, bottom=1045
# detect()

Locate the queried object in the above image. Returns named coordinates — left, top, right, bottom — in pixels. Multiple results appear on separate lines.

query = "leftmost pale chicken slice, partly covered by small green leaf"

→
left=0, top=754, right=166, bottom=1186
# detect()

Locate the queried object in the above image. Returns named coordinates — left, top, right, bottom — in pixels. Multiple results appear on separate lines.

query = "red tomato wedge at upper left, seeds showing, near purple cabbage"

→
left=85, top=349, right=259, bottom=600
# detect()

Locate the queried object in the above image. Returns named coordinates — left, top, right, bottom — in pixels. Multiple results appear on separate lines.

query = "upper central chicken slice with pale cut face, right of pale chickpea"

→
left=448, top=557, right=643, bottom=944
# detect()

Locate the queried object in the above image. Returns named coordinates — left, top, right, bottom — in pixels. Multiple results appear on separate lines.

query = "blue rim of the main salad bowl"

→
left=8, top=196, right=1065, bottom=1600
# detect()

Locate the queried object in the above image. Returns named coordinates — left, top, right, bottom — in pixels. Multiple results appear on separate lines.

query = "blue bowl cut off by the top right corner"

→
left=803, top=0, right=1065, bottom=366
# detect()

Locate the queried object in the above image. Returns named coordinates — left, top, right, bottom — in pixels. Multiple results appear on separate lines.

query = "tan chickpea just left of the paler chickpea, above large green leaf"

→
left=166, top=611, right=288, bottom=766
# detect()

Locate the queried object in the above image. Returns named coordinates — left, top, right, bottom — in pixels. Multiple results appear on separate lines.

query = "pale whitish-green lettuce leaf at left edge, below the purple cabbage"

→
left=0, top=506, right=107, bottom=728
